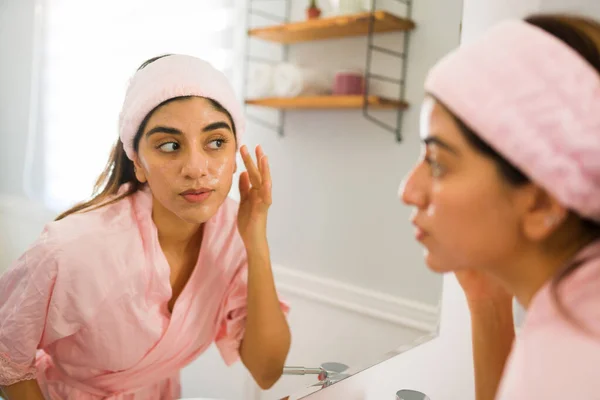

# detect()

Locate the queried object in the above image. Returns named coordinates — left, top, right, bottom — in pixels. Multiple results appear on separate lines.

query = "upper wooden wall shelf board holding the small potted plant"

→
left=248, top=10, right=415, bottom=44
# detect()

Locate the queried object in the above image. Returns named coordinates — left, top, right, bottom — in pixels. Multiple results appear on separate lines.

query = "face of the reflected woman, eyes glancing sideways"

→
left=135, top=97, right=236, bottom=224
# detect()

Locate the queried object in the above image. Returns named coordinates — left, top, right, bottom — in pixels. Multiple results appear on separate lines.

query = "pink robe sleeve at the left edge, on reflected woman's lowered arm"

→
left=0, top=231, right=81, bottom=386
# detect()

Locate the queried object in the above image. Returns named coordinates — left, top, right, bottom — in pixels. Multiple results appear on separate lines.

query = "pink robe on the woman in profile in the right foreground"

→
left=497, top=241, right=600, bottom=400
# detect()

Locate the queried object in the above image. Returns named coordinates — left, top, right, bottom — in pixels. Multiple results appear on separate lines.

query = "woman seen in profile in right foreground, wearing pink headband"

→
left=402, top=15, right=600, bottom=400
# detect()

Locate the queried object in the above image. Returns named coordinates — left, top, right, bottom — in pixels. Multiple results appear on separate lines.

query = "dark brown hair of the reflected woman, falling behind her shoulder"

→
left=56, top=54, right=235, bottom=221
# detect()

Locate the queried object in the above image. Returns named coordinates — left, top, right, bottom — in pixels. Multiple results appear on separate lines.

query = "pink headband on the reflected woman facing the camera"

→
left=119, top=55, right=245, bottom=160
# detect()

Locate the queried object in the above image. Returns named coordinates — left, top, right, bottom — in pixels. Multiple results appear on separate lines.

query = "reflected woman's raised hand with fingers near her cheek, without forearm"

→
left=238, top=145, right=272, bottom=248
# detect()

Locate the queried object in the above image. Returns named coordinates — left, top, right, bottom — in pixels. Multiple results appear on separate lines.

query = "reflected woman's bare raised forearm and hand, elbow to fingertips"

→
left=238, top=146, right=291, bottom=390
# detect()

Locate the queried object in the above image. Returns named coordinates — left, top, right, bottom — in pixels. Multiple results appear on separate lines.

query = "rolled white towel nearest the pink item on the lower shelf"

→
left=273, top=63, right=333, bottom=97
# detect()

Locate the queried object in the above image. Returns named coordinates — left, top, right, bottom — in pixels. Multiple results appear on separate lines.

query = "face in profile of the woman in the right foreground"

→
left=400, top=98, right=520, bottom=272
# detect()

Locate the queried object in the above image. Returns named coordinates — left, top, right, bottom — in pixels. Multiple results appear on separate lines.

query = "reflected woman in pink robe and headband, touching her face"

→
left=0, top=55, right=290, bottom=400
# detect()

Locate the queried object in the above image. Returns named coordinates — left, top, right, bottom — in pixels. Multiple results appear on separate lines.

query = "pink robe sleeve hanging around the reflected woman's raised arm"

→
left=215, top=258, right=290, bottom=366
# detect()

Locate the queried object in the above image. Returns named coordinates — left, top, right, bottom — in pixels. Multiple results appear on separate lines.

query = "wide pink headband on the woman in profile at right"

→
left=425, top=21, right=600, bottom=221
